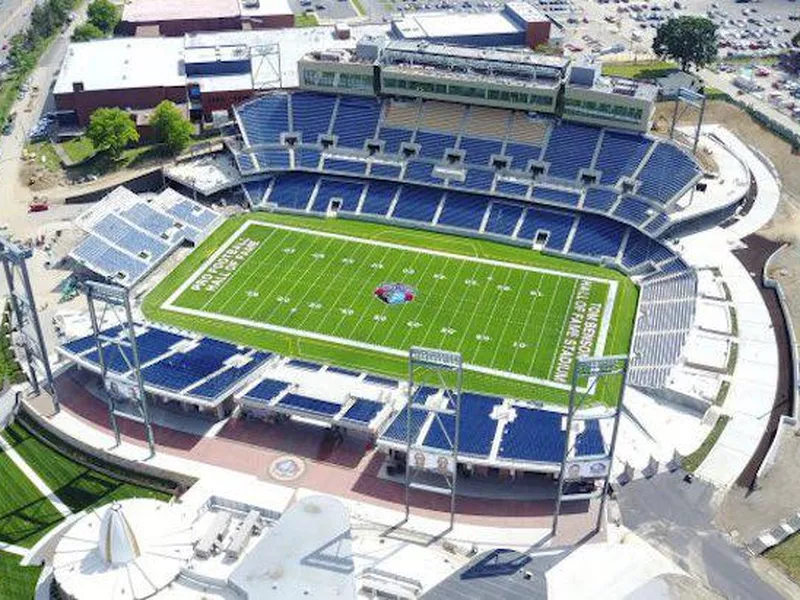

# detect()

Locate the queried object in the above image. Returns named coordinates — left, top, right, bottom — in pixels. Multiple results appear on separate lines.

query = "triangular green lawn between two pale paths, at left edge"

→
left=0, top=440, right=63, bottom=548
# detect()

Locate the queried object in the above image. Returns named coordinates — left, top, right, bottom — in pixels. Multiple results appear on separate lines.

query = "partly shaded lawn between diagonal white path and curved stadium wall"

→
left=3, top=423, right=169, bottom=512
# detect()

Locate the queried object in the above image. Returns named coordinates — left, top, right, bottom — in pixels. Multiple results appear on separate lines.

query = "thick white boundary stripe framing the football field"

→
left=161, top=220, right=618, bottom=392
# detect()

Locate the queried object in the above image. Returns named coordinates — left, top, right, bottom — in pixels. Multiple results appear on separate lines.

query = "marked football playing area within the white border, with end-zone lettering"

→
left=158, top=218, right=621, bottom=390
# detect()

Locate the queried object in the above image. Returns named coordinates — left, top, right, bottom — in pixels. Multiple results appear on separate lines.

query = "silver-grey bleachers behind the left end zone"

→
left=69, top=187, right=222, bottom=286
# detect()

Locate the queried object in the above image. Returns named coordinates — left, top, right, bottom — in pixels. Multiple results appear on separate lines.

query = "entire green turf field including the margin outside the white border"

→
left=144, top=214, right=636, bottom=401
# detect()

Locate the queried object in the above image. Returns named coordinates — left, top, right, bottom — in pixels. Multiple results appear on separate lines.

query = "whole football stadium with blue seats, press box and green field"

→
left=15, top=36, right=792, bottom=596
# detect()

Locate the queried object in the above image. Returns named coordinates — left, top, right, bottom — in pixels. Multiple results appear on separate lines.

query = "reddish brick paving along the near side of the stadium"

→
left=56, top=373, right=597, bottom=544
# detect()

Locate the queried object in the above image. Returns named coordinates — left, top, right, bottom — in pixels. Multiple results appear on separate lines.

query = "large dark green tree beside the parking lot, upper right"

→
left=653, top=16, right=717, bottom=71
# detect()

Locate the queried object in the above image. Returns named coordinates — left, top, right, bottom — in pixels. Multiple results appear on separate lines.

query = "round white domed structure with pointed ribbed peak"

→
left=53, top=498, right=193, bottom=600
